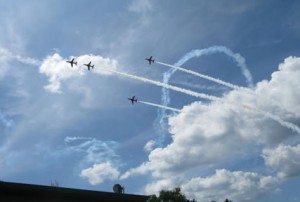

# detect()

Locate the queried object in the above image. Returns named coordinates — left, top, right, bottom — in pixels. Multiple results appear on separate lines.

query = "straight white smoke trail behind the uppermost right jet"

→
left=155, top=61, right=254, bottom=95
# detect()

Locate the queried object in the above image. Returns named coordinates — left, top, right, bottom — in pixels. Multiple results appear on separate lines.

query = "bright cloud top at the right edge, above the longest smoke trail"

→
left=256, top=57, right=300, bottom=118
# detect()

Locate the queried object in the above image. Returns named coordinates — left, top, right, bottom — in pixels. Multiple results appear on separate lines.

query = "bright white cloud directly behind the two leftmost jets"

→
left=40, top=53, right=117, bottom=93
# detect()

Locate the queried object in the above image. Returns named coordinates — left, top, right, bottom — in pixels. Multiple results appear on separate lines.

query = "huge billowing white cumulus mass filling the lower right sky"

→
left=122, top=57, right=300, bottom=201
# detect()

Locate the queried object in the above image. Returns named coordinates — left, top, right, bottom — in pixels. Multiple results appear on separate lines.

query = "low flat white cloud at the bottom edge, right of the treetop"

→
left=182, top=169, right=280, bottom=201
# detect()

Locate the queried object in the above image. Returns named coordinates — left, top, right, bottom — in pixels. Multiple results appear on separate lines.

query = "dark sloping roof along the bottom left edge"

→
left=0, top=182, right=148, bottom=202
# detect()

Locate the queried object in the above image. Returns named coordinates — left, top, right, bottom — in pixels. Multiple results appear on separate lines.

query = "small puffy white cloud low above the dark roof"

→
left=80, top=162, right=120, bottom=185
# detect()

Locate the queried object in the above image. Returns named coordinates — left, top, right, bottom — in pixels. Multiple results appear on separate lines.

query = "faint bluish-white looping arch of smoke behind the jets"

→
left=154, top=46, right=253, bottom=147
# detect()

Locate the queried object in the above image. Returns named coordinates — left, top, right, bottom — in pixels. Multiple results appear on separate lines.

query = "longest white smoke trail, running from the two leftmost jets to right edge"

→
left=106, top=69, right=300, bottom=134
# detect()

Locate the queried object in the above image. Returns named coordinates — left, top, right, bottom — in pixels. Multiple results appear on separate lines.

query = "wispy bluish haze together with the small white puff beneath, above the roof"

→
left=49, top=136, right=120, bottom=185
